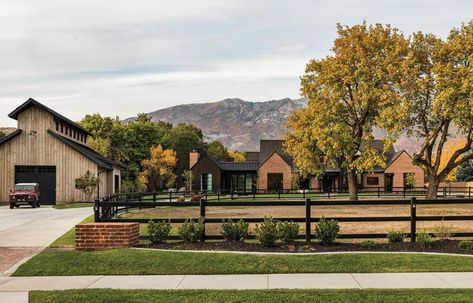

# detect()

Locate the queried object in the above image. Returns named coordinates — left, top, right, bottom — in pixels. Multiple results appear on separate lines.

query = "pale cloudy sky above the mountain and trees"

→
left=0, top=0, right=473, bottom=126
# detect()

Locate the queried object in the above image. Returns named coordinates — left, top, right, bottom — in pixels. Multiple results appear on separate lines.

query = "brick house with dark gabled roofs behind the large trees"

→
left=189, top=140, right=424, bottom=192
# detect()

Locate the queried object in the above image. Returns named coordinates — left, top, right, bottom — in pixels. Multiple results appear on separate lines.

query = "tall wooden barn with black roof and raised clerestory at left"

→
left=0, top=98, right=121, bottom=205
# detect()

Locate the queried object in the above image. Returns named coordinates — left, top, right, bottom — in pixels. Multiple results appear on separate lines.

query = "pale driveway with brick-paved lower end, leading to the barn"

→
left=0, top=206, right=92, bottom=276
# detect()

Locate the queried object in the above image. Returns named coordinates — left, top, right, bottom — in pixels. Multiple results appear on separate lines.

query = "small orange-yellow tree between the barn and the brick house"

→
left=139, top=145, right=177, bottom=191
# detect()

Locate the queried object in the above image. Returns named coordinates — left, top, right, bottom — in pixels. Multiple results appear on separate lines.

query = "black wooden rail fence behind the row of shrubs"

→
left=94, top=195, right=473, bottom=242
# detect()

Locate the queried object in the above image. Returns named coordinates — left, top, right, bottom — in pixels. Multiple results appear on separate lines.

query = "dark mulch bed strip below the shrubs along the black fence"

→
left=138, top=240, right=473, bottom=255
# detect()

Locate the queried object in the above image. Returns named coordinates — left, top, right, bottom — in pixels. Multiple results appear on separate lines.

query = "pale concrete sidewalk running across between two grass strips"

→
left=0, top=272, right=473, bottom=303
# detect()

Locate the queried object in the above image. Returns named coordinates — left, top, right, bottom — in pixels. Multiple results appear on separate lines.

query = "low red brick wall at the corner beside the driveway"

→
left=76, top=223, right=140, bottom=250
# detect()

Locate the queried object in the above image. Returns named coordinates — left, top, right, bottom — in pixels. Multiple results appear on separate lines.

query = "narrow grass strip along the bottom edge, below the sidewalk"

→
left=29, top=289, right=473, bottom=303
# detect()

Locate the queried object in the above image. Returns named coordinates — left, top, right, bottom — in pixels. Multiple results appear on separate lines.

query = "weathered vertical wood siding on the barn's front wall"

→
left=0, top=106, right=98, bottom=204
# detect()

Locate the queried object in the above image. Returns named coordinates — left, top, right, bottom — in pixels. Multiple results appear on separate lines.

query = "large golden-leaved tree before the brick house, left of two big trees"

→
left=285, top=23, right=407, bottom=200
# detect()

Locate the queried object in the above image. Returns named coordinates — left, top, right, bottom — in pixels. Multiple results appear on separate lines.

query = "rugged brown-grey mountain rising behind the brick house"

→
left=125, top=98, right=416, bottom=151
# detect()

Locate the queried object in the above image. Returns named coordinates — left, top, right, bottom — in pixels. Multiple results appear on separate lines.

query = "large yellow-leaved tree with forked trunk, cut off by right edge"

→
left=396, top=22, right=473, bottom=199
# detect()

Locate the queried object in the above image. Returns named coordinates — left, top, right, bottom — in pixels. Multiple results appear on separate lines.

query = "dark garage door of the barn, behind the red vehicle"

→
left=15, top=165, right=56, bottom=205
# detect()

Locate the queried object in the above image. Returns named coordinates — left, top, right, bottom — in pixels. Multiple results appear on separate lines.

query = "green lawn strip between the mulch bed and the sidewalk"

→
left=14, top=249, right=473, bottom=276
